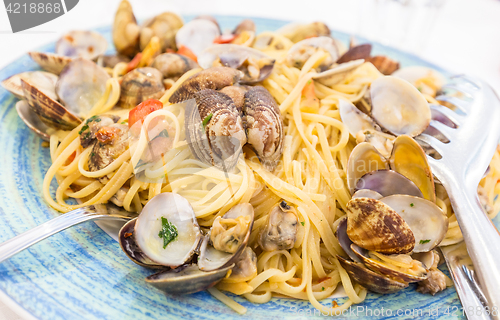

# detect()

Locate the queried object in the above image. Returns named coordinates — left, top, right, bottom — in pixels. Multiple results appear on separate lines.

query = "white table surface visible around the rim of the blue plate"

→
left=0, top=0, right=500, bottom=320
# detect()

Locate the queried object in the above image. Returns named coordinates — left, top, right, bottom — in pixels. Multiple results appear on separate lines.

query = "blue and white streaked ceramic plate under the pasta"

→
left=0, top=17, right=499, bottom=320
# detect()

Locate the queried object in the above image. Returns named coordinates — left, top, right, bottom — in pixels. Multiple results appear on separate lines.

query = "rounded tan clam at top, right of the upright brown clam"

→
left=139, top=12, right=184, bottom=52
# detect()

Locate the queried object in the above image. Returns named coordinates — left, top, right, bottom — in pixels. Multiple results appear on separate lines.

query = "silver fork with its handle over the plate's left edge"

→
left=0, top=203, right=137, bottom=263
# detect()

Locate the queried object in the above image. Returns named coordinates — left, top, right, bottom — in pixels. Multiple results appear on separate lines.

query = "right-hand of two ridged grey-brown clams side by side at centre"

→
left=243, top=86, right=285, bottom=171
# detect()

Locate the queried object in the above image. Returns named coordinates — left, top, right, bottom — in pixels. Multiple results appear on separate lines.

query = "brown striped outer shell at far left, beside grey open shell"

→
left=21, top=79, right=82, bottom=130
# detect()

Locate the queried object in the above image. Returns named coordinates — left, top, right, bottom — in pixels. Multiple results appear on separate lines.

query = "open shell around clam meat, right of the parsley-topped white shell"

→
left=198, top=203, right=254, bottom=271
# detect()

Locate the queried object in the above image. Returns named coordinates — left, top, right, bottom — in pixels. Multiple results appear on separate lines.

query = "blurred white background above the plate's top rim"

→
left=0, top=0, right=500, bottom=92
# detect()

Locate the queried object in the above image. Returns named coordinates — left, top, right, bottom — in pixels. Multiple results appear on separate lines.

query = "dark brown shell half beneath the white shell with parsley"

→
left=146, top=264, right=233, bottom=294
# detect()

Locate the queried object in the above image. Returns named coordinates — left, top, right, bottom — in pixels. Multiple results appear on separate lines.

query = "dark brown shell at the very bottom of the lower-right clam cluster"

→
left=337, top=256, right=408, bottom=294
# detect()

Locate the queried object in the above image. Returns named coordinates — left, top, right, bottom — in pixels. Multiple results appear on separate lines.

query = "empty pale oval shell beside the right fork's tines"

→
left=370, top=76, right=431, bottom=137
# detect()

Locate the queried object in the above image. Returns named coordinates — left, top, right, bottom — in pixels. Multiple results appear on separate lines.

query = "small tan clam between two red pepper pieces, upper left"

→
left=151, top=53, right=199, bottom=80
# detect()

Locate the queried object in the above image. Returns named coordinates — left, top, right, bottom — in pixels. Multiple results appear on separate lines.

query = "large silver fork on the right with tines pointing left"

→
left=416, top=75, right=500, bottom=319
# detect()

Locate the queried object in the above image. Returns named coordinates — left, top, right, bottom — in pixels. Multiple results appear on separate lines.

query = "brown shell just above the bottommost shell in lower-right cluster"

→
left=351, top=244, right=428, bottom=283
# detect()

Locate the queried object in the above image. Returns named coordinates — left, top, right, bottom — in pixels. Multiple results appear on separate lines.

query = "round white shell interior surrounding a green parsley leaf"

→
left=134, top=193, right=202, bottom=268
